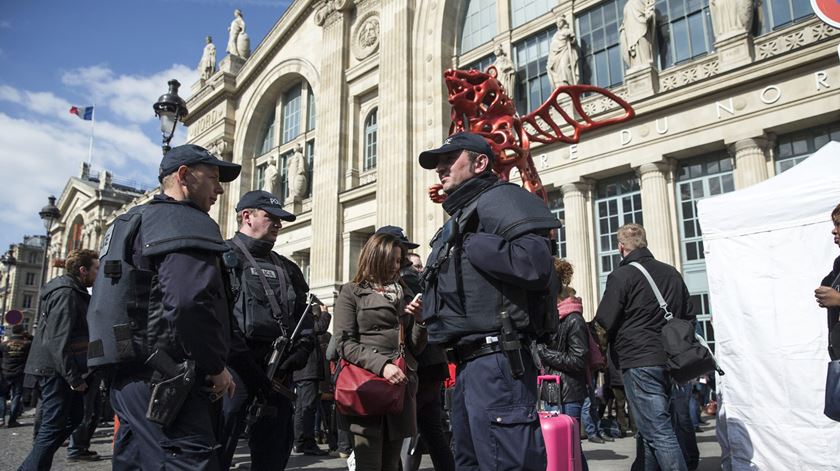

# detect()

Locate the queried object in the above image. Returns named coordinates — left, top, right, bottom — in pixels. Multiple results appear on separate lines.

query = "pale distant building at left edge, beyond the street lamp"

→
left=0, top=236, right=47, bottom=330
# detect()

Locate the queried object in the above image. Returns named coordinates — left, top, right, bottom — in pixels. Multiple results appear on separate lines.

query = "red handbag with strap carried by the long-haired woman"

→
left=335, top=317, right=405, bottom=417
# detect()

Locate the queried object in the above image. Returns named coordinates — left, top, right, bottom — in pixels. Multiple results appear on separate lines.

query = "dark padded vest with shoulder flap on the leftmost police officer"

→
left=87, top=200, right=229, bottom=367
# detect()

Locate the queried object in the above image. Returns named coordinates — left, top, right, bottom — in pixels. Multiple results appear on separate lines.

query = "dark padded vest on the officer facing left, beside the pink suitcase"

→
left=423, top=182, right=560, bottom=345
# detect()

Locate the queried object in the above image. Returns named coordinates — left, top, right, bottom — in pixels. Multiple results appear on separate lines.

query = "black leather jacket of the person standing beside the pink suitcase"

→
left=537, top=298, right=589, bottom=404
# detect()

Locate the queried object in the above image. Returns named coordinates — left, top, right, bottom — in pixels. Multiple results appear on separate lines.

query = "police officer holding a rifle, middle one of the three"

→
left=222, top=191, right=317, bottom=470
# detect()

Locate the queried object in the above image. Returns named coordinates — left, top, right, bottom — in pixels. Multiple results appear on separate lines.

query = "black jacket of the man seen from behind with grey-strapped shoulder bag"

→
left=595, top=248, right=694, bottom=369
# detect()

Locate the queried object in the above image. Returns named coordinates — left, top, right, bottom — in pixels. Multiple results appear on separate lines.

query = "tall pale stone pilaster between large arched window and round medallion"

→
left=309, top=10, right=350, bottom=299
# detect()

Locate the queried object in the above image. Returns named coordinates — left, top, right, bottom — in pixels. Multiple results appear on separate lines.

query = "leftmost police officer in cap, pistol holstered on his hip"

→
left=88, top=144, right=241, bottom=470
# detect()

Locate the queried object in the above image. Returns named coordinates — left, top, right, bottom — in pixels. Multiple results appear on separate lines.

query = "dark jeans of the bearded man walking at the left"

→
left=18, top=375, right=84, bottom=471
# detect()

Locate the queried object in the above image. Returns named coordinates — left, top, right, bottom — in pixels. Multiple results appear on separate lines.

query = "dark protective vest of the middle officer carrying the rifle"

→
left=227, top=241, right=302, bottom=342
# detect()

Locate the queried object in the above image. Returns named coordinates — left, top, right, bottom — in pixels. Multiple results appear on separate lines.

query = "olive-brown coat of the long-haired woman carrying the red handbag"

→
left=333, top=283, right=426, bottom=440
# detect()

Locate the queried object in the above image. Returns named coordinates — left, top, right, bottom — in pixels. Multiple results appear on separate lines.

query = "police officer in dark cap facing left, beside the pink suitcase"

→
left=419, top=132, right=559, bottom=470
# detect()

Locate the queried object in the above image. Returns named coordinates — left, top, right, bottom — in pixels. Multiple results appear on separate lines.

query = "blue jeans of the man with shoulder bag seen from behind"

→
left=622, top=366, right=688, bottom=471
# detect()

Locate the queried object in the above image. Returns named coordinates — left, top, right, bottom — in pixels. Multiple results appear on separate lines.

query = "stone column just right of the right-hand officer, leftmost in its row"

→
left=562, top=182, right=597, bottom=320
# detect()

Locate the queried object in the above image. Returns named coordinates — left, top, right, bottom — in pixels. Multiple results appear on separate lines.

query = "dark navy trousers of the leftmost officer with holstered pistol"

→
left=111, top=377, right=221, bottom=471
